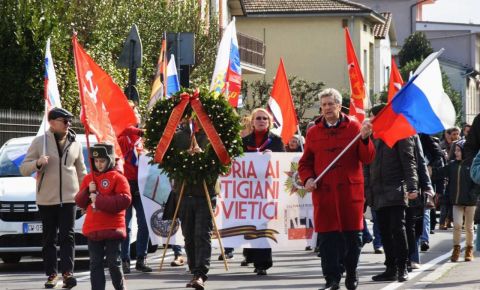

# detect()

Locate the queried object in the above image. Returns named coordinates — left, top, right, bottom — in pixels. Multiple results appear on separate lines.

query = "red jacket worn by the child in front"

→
left=75, top=170, right=132, bottom=241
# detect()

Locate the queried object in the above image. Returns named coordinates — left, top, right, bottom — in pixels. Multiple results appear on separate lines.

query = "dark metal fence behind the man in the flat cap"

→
left=0, top=109, right=84, bottom=145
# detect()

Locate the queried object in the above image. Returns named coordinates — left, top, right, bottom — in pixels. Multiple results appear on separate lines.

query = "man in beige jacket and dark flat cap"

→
left=20, top=108, right=86, bottom=288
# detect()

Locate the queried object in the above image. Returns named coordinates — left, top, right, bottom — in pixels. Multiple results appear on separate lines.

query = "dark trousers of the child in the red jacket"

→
left=88, top=240, right=124, bottom=290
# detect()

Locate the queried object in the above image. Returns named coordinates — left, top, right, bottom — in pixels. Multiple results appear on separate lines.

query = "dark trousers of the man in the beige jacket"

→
left=38, top=203, right=76, bottom=276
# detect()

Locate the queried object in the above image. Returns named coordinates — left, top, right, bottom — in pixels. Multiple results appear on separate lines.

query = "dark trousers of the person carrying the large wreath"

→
left=179, top=195, right=216, bottom=281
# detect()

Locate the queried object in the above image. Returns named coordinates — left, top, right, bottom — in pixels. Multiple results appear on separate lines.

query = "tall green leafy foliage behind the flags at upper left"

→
left=0, top=0, right=219, bottom=114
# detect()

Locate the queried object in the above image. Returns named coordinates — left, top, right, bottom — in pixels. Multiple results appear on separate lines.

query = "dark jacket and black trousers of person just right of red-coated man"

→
left=369, top=137, right=418, bottom=282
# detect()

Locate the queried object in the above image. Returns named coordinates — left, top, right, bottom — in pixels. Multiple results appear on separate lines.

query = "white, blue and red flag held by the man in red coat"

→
left=372, top=50, right=455, bottom=147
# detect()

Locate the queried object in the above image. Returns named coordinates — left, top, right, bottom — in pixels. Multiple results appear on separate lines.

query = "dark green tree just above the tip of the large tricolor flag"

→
left=398, top=32, right=433, bottom=67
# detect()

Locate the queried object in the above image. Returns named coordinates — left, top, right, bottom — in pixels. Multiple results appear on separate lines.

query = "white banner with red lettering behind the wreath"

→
left=138, top=153, right=314, bottom=249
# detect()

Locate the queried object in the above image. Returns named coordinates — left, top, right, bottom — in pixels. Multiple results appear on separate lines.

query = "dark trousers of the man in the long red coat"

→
left=318, top=231, right=362, bottom=283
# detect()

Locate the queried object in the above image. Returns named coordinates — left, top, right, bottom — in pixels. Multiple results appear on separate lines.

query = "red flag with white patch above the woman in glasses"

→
left=268, top=59, right=298, bottom=144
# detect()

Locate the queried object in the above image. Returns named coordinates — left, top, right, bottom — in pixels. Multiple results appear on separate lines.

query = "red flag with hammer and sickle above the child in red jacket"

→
left=72, top=36, right=137, bottom=157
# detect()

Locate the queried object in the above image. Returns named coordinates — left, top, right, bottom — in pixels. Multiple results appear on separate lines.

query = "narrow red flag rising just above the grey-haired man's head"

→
left=345, top=27, right=366, bottom=122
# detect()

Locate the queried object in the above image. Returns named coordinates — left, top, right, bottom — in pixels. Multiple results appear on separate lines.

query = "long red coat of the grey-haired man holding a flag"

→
left=298, top=114, right=375, bottom=233
